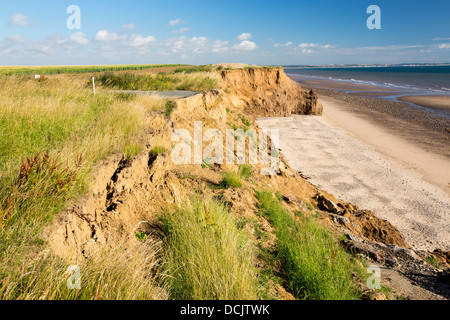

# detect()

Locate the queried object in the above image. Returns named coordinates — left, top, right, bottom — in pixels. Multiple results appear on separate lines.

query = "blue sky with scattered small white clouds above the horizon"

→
left=0, top=0, right=450, bottom=65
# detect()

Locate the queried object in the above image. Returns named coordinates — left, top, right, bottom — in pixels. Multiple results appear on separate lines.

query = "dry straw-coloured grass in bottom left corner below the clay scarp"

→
left=0, top=239, right=167, bottom=300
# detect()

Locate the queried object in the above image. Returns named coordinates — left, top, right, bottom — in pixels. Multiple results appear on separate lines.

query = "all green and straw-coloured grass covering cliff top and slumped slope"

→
left=0, top=66, right=372, bottom=299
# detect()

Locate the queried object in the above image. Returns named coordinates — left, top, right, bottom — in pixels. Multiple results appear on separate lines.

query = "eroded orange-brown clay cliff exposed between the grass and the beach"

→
left=45, top=68, right=448, bottom=299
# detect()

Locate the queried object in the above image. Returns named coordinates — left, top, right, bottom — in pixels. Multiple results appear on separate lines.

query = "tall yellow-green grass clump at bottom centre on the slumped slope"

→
left=162, top=199, right=258, bottom=300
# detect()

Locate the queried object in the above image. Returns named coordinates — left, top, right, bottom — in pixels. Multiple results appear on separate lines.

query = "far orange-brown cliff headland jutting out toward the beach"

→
left=221, top=68, right=323, bottom=118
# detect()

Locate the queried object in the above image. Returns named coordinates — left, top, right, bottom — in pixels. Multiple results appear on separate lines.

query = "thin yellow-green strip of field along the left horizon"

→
left=0, top=64, right=183, bottom=75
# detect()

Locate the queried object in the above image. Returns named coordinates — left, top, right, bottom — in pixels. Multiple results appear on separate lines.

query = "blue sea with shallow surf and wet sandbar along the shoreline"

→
left=286, top=64, right=450, bottom=120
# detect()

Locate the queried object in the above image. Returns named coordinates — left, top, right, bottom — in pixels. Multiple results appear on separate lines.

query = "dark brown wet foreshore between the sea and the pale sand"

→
left=286, top=70, right=450, bottom=172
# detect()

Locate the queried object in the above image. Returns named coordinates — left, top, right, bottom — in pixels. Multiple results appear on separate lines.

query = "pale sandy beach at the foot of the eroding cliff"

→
left=258, top=96, right=450, bottom=250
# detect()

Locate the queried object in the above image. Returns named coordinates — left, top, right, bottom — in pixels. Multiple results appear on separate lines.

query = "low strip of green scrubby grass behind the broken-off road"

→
left=94, top=69, right=219, bottom=91
